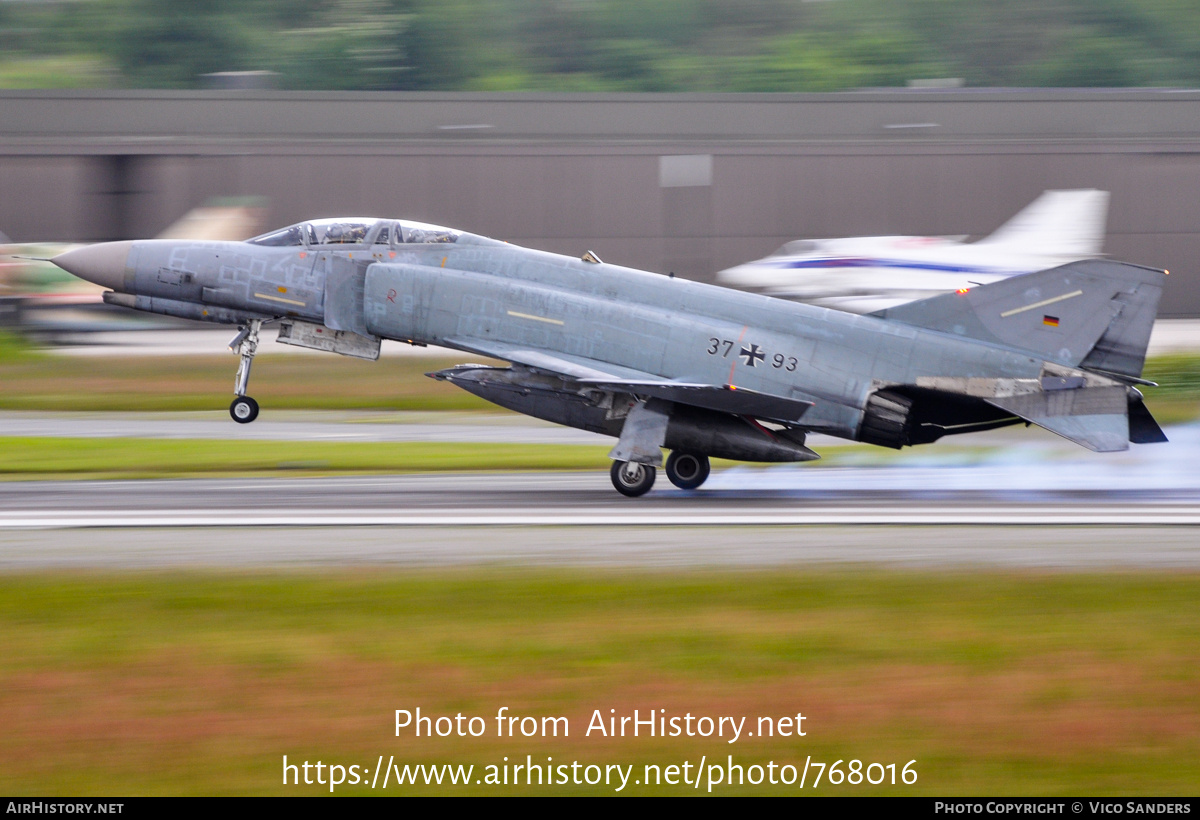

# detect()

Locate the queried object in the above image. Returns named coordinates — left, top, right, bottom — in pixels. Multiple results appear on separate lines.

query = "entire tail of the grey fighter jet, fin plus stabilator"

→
left=872, top=259, right=1166, bottom=453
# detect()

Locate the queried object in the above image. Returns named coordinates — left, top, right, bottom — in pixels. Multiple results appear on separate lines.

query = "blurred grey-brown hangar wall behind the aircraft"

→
left=0, top=90, right=1200, bottom=317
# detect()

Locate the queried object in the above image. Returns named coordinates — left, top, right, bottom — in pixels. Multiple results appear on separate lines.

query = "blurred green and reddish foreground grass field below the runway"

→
left=0, top=567, right=1200, bottom=795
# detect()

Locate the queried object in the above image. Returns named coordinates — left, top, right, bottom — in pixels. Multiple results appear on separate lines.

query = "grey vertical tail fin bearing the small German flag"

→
left=871, top=259, right=1164, bottom=378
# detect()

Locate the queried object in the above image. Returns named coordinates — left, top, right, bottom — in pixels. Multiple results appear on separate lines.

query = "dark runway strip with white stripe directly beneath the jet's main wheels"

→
left=0, top=466, right=1200, bottom=513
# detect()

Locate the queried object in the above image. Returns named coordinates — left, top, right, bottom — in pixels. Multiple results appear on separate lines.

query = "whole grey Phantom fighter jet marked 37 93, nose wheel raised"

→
left=54, top=219, right=1165, bottom=496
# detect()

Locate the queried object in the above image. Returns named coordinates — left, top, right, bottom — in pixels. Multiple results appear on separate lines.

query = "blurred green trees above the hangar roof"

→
left=0, top=0, right=1200, bottom=91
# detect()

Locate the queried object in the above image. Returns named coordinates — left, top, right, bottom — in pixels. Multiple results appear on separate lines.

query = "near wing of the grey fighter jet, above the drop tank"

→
left=445, top=339, right=812, bottom=424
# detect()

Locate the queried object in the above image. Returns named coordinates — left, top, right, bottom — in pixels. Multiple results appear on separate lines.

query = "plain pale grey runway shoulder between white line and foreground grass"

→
left=0, top=526, right=1200, bottom=573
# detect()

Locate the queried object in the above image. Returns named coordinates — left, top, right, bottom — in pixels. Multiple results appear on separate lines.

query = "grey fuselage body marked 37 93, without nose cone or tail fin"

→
left=77, top=221, right=1042, bottom=438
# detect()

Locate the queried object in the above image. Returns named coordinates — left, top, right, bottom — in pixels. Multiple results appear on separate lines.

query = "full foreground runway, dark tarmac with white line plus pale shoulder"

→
left=0, top=468, right=1200, bottom=571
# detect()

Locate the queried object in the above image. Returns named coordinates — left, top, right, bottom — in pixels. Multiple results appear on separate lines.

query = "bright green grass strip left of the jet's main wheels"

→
left=0, top=437, right=610, bottom=479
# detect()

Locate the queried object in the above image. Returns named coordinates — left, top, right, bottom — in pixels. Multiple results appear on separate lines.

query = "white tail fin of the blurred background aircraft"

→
left=976, top=188, right=1109, bottom=258
